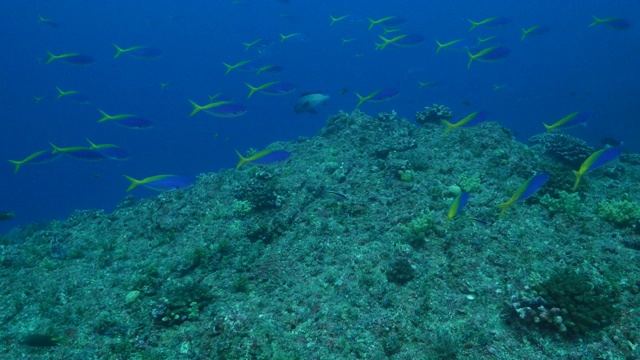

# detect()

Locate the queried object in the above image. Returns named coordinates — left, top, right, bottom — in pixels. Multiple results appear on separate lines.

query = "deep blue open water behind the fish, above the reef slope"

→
left=0, top=0, right=640, bottom=232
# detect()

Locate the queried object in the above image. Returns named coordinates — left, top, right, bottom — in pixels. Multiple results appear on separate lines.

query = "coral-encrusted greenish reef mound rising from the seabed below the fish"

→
left=0, top=107, right=640, bottom=360
